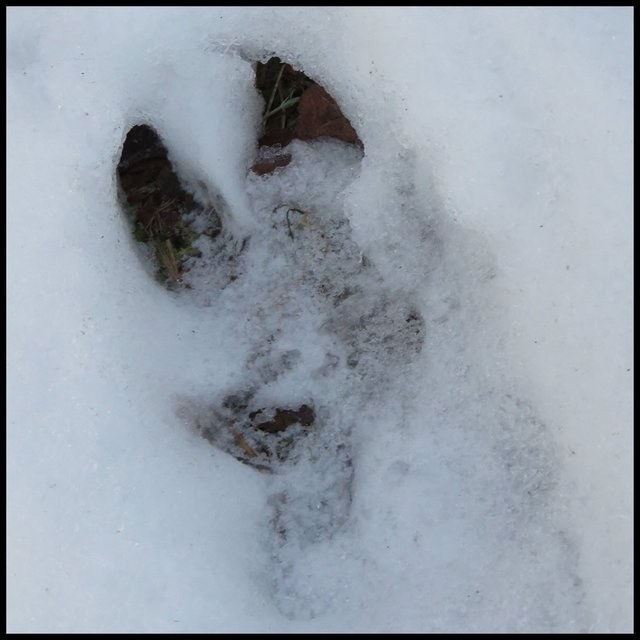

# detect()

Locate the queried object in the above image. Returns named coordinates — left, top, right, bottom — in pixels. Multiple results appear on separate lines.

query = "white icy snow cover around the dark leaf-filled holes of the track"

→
left=7, top=7, right=633, bottom=632
